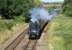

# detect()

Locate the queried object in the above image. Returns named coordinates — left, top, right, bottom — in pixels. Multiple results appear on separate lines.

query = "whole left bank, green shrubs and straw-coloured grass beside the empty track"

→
left=0, top=16, right=26, bottom=44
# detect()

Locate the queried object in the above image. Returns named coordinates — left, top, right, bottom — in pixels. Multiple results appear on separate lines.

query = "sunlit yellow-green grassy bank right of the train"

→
left=48, top=15, right=72, bottom=50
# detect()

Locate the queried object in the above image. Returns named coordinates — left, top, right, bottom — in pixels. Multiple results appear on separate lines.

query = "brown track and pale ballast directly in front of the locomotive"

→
left=14, top=35, right=37, bottom=50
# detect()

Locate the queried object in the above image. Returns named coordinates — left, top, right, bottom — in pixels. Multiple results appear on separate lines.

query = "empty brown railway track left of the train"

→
left=3, top=28, right=28, bottom=50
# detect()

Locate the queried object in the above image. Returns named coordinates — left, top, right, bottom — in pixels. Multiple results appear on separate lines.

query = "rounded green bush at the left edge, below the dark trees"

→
left=0, top=20, right=14, bottom=31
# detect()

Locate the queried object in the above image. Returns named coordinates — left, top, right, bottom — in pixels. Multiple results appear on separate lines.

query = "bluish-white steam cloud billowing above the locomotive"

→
left=30, top=8, right=58, bottom=22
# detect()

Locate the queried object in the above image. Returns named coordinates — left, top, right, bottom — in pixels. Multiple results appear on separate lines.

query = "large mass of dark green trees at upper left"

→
left=0, top=0, right=33, bottom=19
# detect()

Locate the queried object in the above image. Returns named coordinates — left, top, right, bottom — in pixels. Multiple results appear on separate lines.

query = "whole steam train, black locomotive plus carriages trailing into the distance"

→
left=28, top=9, right=60, bottom=40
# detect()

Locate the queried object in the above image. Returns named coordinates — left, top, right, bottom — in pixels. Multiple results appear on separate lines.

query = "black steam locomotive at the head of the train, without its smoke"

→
left=28, top=20, right=48, bottom=40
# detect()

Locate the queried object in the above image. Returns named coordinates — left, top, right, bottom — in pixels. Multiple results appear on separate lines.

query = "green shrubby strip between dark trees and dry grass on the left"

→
left=0, top=16, right=25, bottom=32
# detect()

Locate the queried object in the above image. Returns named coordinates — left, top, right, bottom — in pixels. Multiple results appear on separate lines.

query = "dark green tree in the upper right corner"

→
left=63, top=0, right=72, bottom=16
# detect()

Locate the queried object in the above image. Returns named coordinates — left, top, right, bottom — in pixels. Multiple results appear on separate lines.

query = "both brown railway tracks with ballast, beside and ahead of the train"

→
left=4, top=22, right=49, bottom=50
